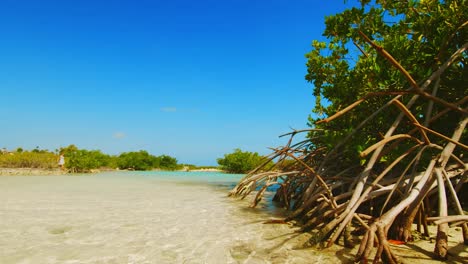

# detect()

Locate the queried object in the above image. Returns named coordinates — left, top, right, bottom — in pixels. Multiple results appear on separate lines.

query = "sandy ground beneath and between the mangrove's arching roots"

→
left=249, top=195, right=468, bottom=264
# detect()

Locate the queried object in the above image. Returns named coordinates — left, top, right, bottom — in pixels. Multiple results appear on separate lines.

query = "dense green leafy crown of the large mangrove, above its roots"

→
left=306, top=0, right=468, bottom=172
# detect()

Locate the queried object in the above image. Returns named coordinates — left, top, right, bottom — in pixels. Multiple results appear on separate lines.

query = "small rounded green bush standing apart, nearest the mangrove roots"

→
left=217, top=149, right=266, bottom=173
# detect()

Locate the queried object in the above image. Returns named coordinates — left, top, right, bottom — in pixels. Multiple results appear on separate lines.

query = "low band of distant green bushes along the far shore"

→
left=0, top=145, right=281, bottom=173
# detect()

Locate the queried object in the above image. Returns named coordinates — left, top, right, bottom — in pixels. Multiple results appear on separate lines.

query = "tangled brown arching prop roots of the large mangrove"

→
left=230, top=38, right=468, bottom=263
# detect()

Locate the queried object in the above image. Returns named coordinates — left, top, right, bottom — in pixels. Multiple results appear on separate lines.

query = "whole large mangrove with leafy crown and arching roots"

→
left=231, top=0, right=468, bottom=263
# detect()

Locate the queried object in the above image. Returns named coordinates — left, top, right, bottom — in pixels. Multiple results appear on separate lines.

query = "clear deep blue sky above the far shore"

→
left=0, top=0, right=358, bottom=165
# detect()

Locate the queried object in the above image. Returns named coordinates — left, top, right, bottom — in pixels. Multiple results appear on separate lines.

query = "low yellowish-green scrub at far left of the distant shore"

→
left=0, top=150, right=57, bottom=169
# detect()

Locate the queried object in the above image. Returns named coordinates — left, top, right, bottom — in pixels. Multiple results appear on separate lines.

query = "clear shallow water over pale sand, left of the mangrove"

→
left=0, top=172, right=336, bottom=264
